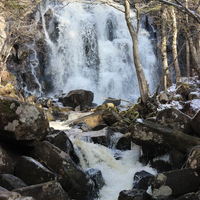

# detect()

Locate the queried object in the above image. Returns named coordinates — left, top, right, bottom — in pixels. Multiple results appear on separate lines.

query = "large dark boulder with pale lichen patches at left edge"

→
left=0, top=96, right=49, bottom=146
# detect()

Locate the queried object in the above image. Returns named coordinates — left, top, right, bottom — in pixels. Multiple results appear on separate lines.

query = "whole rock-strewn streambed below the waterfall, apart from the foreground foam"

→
left=0, top=74, right=200, bottom=200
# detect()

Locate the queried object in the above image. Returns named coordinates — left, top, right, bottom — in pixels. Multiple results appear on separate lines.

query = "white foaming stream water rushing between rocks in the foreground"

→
left=72, top=139, right=156, bottom=200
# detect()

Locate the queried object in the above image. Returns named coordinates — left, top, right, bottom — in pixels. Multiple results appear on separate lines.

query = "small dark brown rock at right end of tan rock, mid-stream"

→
left=102, top=107, right=123, bottom=126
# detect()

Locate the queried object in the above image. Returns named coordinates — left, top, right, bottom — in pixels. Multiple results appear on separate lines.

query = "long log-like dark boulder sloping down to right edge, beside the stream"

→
left=131, top=119, right=200, bottom=153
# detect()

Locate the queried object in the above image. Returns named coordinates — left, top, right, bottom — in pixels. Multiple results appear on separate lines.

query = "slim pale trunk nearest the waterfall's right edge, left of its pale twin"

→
left=161, top=4, right=169, bottom=90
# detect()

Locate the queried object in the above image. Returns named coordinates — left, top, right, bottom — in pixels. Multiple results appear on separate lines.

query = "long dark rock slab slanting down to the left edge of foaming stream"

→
left=32, top=141, right=94, bottom=200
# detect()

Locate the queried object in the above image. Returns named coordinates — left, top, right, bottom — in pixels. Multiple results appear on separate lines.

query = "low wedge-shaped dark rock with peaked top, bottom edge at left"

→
left=13, top=181, right=71, bottom=200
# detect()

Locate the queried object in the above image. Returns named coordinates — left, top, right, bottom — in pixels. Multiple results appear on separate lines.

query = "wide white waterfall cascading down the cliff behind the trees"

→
left=43, top=3, right=156, bottom=104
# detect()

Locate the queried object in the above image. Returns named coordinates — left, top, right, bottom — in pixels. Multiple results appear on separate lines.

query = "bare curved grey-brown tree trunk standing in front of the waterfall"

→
left=124, top=0, right=148, bottom=105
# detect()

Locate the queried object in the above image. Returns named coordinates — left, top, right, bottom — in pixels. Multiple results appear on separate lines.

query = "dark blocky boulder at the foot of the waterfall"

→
left=59, top=90, right=94, bottom=108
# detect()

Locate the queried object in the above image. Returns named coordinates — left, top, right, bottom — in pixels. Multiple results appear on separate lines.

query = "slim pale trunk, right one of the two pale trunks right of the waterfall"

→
left=171, top=8, right=181, bottom=83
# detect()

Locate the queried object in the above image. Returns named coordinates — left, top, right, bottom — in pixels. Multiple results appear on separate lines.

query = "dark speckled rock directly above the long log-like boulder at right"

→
left=156, top=108, right=192, bottom=134
